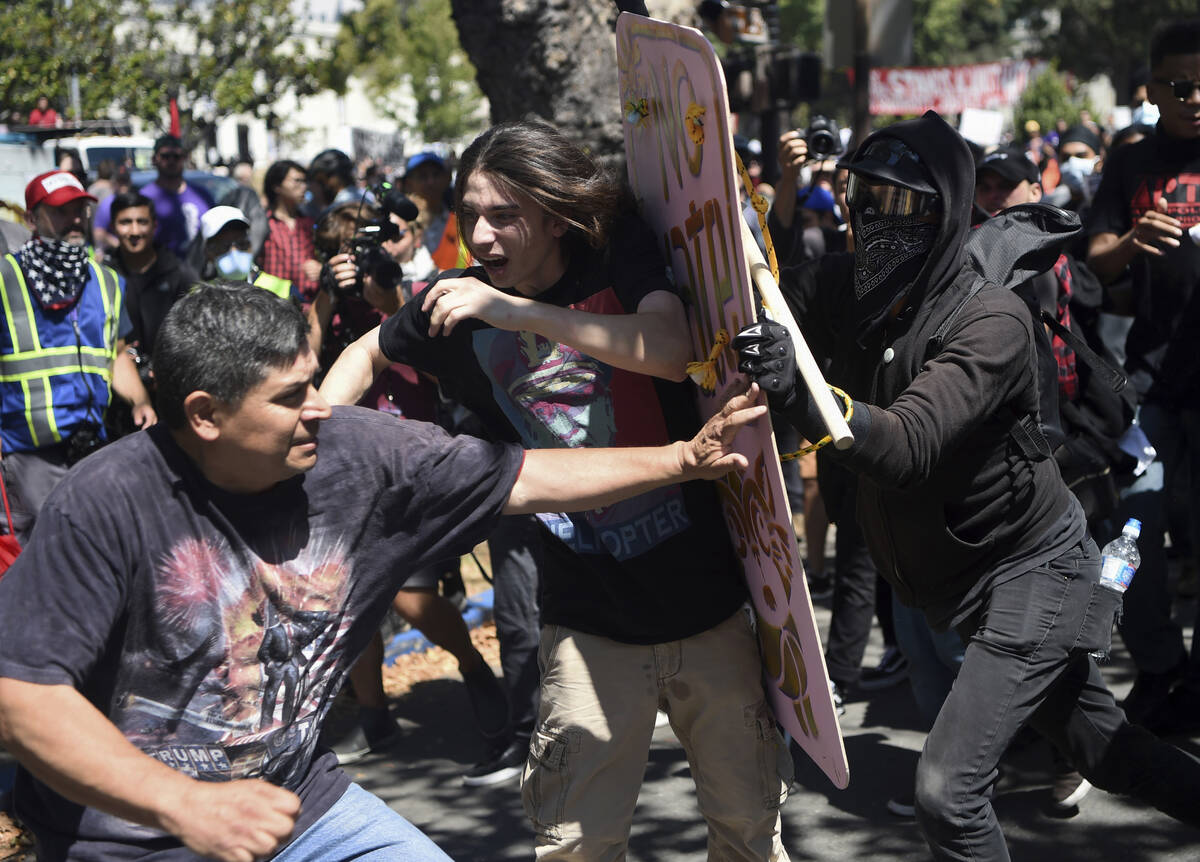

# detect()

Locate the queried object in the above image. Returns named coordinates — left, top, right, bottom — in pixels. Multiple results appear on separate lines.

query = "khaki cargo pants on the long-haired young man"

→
left=521, top=610, right=792, bottom=862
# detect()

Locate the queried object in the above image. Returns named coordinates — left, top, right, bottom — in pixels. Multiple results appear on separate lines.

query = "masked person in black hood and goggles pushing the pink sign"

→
left=734, top=112, right=1200, bottom=860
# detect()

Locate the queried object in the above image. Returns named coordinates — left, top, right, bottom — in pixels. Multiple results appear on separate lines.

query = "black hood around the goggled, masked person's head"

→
left=847, top=110, right=974, bottom=339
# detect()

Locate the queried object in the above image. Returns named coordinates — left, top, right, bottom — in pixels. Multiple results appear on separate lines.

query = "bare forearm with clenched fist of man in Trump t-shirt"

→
left=0, top=677, right=300, bottom=862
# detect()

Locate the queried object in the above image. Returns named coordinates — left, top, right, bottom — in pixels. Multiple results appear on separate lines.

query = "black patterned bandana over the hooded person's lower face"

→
left=851, top=212, right=937, bottom=307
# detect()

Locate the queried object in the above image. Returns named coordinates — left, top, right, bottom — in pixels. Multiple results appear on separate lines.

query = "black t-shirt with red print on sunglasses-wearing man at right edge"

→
left=1087, top=128, right=1200, bottom=406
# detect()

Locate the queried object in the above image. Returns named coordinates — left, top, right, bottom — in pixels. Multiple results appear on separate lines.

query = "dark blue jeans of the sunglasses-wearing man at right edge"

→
left=1102, top=403, right=1200, bottom=677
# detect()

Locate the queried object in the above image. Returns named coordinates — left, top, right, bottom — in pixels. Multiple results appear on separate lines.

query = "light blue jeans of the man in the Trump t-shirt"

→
left=272, top=784, right=450, bottom=862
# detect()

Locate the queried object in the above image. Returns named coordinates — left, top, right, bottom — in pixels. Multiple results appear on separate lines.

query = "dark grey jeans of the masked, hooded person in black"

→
left=916, top=539, right=1200, bottom=862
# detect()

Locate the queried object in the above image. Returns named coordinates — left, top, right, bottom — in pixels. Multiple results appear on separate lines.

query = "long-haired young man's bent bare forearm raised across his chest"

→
left=421, top=276, right=691, bottom=381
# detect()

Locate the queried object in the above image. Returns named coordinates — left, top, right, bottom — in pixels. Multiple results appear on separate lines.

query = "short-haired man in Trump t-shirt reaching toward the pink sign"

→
left=0, top=285, right=764, bottom=862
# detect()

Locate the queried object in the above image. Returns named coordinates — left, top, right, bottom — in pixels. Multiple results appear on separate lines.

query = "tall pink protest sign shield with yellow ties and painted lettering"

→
left=617, top=13, right=850, bottom=788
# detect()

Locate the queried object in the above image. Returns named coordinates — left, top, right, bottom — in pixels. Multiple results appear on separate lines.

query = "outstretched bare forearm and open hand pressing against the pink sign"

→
left=504, top=385, right=767, bottom=515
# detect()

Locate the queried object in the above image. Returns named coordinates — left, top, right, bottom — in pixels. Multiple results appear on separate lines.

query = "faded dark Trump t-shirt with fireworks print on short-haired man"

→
left=0, top=407, right=524, bottom=860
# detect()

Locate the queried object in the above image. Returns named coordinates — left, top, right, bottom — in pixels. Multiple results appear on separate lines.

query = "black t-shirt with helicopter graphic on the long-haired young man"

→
left=379, top=217, right=746, bottom=643
